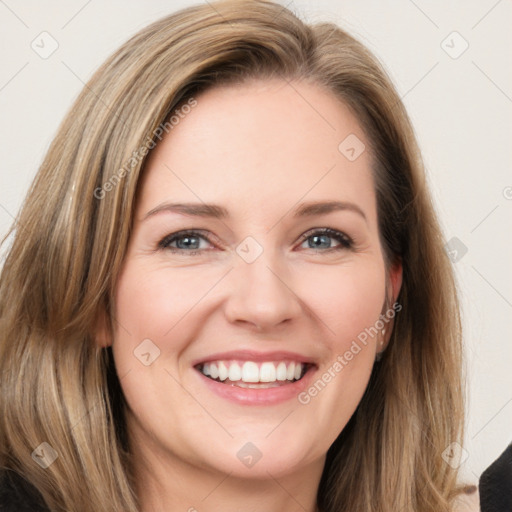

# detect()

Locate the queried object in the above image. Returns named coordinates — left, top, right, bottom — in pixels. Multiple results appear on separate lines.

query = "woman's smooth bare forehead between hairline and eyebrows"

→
left=139, top=80, right=375, bottom=224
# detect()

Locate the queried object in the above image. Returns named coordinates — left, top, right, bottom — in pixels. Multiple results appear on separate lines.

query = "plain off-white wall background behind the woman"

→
left=0, top=0, right=512, bottom=481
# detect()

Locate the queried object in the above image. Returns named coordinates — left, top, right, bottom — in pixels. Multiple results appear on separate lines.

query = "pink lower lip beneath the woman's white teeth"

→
left=196, top=367, right=316, bottom=405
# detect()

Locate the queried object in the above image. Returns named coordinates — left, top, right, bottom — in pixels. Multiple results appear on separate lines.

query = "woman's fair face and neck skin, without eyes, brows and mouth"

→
left=105, top=81, right=401, bottom=512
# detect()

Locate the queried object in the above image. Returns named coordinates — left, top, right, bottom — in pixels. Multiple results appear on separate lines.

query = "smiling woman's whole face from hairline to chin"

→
left=113, top=81, right=399, bottom=478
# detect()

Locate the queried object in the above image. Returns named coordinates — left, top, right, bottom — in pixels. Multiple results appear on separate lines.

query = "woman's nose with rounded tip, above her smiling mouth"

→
left=225, top=252, right=302, bottom=331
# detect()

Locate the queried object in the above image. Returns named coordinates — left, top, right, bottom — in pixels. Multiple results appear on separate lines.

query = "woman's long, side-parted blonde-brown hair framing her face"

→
left=0, top=0, right=463, bottom=512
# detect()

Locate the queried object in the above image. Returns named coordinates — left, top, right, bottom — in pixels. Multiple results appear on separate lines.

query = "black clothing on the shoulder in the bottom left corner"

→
left=0, top=470, right=49, bottom=512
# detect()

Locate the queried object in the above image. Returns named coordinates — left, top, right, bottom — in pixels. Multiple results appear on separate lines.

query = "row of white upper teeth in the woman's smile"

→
left=200, top=361, right=305, bottom=382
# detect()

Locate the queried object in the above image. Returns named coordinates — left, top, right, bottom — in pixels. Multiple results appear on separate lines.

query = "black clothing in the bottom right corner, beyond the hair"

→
left=478, top=444, right=512, bottom=512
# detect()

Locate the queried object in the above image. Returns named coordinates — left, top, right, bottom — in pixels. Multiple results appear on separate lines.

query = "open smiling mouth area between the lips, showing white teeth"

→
left=195, top=360, right=314, bottom=389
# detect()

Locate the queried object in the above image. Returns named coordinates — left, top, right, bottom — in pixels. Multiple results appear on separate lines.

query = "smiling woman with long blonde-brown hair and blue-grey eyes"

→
left=0, top=0, right=472, bottom=512
